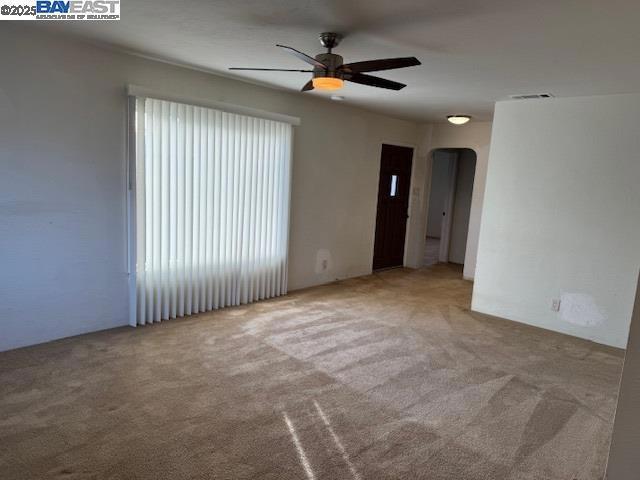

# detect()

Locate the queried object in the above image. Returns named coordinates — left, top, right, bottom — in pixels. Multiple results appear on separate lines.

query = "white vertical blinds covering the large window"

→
left=132, top=98, right=292, bottom=325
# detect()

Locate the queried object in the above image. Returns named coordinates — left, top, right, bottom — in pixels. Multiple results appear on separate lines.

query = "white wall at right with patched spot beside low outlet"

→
left=472, top=95, right=640, bottom=347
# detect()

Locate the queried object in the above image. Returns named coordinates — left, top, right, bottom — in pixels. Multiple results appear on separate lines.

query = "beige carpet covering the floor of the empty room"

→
left=0, top=265, right=622, bottom=480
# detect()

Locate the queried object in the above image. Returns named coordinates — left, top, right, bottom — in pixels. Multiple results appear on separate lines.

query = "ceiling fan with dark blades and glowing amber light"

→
left=229, top=32, right=421, bottom=92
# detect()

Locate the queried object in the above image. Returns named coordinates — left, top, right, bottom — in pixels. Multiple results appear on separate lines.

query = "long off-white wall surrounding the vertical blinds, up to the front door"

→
left=0, top=22, right=419, bottom=350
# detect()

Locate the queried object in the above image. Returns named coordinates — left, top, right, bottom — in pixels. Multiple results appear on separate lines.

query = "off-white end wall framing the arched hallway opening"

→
left=405, top=120, right=491, bottom=279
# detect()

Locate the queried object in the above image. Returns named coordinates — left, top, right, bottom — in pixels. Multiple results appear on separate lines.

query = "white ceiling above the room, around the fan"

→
left=42, top=0, right=640, bottom=121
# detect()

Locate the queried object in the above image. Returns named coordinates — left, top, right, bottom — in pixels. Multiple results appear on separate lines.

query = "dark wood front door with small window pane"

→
left=373, top=145, right=413, bottom=270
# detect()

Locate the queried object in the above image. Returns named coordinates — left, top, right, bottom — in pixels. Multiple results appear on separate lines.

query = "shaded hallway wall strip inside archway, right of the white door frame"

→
left=449, top=149, right=476, bottom=265
